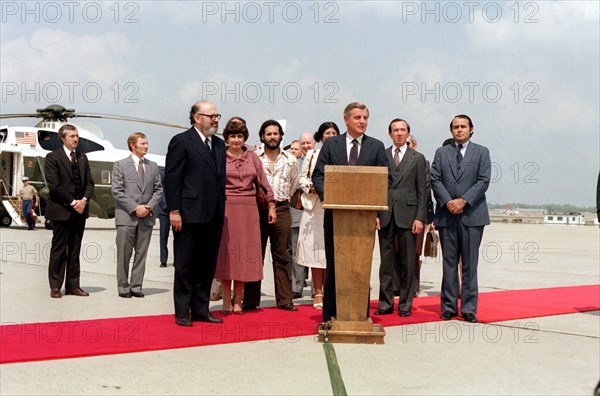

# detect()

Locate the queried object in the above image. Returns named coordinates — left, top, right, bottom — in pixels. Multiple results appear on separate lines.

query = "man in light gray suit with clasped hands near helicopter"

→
left=112, top=132, right=162, bottom=298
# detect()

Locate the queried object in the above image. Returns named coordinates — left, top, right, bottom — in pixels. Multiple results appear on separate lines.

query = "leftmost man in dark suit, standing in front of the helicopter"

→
left=44, top=124, right=94, bottom=298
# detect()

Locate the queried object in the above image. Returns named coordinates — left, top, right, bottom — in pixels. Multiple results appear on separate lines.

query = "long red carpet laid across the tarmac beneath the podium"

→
left=0, top=285, right=600, bottom=363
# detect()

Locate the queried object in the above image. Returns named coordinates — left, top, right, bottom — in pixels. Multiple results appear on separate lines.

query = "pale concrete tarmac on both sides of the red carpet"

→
left=0, top=219, right=600, bottom=395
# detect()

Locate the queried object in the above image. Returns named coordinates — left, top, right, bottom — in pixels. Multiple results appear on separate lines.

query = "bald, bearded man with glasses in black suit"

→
left=164, top=101, right=225, bottom=326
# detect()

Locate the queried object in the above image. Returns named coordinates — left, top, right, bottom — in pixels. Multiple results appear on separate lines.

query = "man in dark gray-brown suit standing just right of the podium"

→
left=375, top=118, right=427, bottom=316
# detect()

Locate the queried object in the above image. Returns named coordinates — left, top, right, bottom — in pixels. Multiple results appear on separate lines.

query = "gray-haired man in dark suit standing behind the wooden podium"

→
left=312, top=102, right=388, bottom=321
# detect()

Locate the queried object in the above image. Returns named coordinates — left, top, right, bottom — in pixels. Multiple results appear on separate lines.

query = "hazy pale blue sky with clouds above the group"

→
left=0, top=1, right=600, bottom=206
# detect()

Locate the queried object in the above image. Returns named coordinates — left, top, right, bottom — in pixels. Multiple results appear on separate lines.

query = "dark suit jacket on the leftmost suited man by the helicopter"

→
left=44, top=146, right=94, bottom=221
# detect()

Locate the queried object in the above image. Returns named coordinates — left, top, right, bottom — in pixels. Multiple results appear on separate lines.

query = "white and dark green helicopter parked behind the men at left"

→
left=0, top=105, right=184, bottom=228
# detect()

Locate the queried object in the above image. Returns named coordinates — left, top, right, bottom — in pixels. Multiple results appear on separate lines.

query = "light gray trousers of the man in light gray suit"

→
left=117, top=222, right=152, bottom=293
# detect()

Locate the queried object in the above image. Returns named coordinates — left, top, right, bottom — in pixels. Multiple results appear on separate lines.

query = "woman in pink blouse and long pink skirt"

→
left=215, top=117, right=277, bottom=315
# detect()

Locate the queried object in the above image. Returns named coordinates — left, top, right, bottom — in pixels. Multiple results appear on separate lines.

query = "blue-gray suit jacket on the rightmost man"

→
left=431, top=141, right=492, bottom=227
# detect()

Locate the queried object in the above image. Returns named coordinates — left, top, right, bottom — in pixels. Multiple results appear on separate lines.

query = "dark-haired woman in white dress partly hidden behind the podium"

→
left=296, top=122, right=340, bottom=309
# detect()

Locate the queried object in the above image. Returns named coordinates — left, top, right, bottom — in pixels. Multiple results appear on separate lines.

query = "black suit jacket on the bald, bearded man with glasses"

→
left=164, top=127, right=226, bottom=223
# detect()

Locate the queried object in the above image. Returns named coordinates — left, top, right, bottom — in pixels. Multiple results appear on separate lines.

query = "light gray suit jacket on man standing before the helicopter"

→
left=112, top=156, right=162, bottom=227
